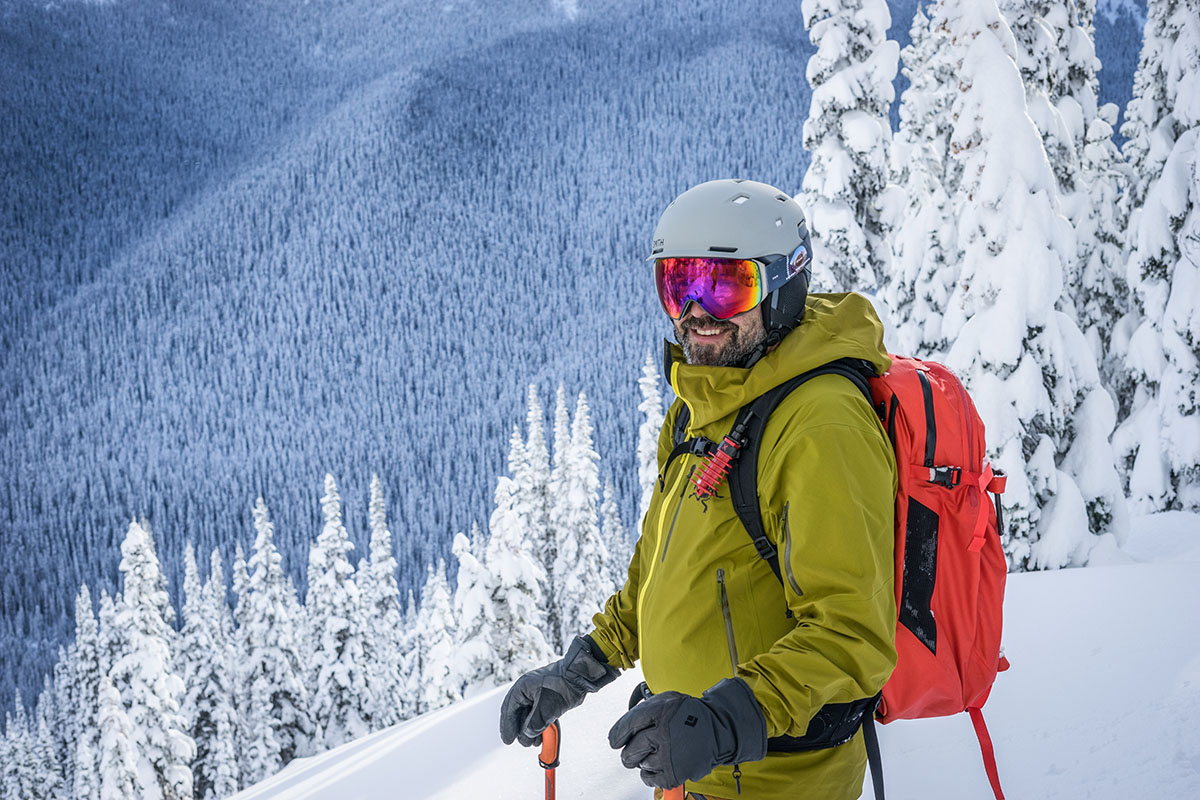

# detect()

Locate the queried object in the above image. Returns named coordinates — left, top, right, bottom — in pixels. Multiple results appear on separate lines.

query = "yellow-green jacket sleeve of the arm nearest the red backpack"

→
left=737, top=377, right=896, bottom=736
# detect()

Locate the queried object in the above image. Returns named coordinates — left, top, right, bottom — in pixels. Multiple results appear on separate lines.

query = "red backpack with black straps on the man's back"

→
left=674, top=356, right=1008, bottom=800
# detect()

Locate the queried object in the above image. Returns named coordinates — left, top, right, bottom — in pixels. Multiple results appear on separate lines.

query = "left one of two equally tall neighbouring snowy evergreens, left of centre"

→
left=305, top=475, right=374, bottom=748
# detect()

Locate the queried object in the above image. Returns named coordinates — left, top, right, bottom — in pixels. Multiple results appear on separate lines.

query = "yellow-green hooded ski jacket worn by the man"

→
left=590, top=294, right=896, bottom=800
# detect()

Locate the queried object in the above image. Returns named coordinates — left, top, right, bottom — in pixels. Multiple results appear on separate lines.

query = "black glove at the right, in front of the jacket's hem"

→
left=608, top=678, right=767, bottom=789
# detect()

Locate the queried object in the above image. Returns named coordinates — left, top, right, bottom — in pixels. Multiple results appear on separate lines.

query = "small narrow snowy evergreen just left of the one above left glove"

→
left=452, top=525, right=497, bottom=697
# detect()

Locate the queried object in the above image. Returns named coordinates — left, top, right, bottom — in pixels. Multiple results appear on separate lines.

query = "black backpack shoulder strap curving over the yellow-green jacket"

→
left=724, top=359, right=875, bottom=583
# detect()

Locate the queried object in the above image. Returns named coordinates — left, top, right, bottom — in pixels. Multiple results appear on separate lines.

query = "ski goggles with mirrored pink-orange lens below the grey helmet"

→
left=654, top=245, right=809, bottom=319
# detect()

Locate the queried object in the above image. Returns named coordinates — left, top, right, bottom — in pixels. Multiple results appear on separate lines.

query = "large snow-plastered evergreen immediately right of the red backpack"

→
left=934, top=0, right=1124, bottom=569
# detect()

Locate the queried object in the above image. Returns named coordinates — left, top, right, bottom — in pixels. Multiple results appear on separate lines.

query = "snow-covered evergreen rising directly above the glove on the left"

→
left=486, top=476, right=552, bottom=684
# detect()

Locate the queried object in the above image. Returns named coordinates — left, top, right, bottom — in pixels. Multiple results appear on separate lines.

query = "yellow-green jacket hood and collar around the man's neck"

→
left=665, top=293, right=892, bottom=428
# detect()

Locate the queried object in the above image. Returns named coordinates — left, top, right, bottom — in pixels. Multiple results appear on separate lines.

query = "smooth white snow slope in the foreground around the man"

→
left=229, top=513, right=1200, bottom=800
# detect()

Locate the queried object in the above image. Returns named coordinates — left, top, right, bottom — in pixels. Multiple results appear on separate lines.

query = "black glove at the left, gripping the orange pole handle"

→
left=500, top=636, right=620, bottom=747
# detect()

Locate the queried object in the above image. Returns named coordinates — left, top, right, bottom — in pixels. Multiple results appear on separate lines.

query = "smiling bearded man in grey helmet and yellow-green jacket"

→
left=500, top=180, right=896, bottom=800
